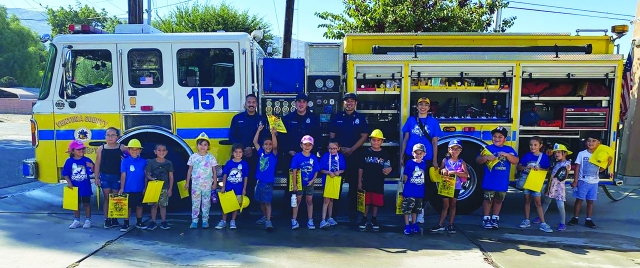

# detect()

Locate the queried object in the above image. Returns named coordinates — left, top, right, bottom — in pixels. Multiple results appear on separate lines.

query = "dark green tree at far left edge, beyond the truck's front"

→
left=0, top=6, right=46, bottom=87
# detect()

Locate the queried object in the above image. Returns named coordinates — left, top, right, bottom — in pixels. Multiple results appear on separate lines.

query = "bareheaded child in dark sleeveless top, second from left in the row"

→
left=94, top=127, right=127, bottom=229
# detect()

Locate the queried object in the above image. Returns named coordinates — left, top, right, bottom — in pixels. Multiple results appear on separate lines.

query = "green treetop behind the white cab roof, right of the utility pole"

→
left=152, top=2, right=277, bottom=53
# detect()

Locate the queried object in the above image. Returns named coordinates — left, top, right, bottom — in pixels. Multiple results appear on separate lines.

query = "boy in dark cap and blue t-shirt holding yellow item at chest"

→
left=476, top=126, right=519, bottom=229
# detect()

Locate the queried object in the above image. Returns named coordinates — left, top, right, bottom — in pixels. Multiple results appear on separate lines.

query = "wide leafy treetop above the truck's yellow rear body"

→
left=315, top=0, right=516, bottom=39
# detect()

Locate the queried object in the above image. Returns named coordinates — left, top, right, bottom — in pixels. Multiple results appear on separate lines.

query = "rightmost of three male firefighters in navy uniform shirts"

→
left=329, top=93, right=369, bottom=219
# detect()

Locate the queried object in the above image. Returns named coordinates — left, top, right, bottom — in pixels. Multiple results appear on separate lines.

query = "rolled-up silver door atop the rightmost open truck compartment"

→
left=522, top=65, right=616, bottom=78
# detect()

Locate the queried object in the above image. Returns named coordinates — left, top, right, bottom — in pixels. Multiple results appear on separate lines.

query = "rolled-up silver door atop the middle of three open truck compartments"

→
left=411, top=65, right=514, bottom=78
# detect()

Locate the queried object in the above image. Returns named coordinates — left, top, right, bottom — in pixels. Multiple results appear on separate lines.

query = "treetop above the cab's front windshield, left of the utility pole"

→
left=47, top=2, right=122, bottom=37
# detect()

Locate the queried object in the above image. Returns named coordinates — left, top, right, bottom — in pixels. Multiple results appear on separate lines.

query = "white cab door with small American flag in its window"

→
left=118, top=43, right=174, bottom=112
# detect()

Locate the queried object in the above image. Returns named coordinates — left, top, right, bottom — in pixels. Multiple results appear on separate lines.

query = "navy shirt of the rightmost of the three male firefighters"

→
left=329, top=111, right=369, bottom=147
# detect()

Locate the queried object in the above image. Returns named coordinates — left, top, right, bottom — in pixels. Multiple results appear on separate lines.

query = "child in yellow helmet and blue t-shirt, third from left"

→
left=118, top=139, right=147, bottom=232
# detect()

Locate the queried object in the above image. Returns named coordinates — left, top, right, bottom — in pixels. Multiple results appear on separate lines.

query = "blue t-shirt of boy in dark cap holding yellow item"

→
left=482, top=144, right=518, bottom=192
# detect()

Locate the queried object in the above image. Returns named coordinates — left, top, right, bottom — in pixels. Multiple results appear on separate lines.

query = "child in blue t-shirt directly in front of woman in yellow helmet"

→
left=402, top=143, right=427, bottom=235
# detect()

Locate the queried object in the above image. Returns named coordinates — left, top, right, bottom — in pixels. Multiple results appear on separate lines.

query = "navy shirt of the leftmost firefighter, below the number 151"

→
left=229, top=112, right=268, bottom=147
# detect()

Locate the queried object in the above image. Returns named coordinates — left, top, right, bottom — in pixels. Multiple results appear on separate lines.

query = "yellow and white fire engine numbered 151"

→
left=23, top=22, right=628, bottom=213
